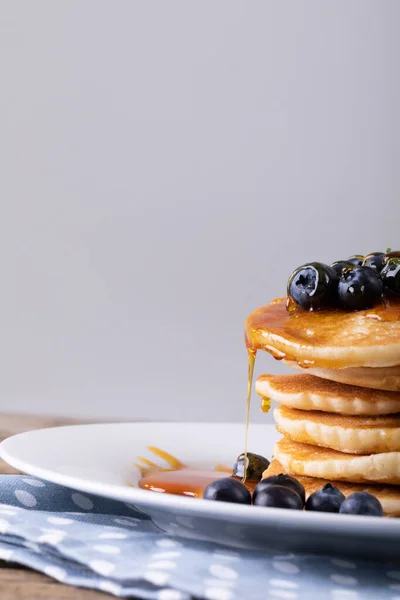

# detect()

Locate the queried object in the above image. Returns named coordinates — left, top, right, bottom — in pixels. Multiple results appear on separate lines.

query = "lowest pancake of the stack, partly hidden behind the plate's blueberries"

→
left=263, top=460, right=400, bottom=517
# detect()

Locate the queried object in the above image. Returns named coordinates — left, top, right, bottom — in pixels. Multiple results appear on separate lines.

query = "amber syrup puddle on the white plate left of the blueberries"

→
left=135, top=448, right=257, bottom=498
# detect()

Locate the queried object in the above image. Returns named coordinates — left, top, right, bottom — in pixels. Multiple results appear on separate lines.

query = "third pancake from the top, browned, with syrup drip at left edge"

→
left=255, top=373, right=400, bottom=415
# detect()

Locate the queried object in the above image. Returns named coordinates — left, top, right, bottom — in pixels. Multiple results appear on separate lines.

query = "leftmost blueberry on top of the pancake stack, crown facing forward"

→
left=287, top=262, right=338, bottom=310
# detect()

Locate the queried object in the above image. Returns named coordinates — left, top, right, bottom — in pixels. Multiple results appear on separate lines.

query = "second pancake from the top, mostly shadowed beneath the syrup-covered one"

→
left=284, top=360, right=400, bottom=392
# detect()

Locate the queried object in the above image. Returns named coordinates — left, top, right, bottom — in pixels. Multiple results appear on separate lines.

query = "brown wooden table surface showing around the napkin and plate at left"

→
left=0, top=415, right=123, bottom=600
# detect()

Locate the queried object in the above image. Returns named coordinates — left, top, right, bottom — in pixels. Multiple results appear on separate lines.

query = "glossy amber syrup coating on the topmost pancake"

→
left=245, top=296, right=400, bottom=369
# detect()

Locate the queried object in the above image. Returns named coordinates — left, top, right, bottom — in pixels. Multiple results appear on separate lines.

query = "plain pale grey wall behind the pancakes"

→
left=0, top=0, right=400, bottom=420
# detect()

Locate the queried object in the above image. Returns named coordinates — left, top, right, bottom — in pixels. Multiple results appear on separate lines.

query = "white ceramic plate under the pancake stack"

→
left=0, top=423, right=400, bottom=560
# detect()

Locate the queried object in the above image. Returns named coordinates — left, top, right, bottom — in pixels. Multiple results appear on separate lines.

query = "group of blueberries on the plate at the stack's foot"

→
left=203, top=452, right=383, bottom=517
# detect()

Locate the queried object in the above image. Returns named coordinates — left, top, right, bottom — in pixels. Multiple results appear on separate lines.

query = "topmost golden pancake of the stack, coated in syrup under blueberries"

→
left=245, top=298, right=400, bottom=369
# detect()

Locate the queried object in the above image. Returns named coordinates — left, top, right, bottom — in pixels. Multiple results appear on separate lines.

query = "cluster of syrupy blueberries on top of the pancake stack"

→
left=287, top=252, right=400, bottom=310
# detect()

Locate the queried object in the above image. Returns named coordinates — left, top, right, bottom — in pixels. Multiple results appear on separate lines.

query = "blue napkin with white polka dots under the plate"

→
left=0, top=475, right=400, bottom=600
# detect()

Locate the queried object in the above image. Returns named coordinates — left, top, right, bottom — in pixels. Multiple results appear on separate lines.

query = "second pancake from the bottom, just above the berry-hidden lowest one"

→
left=274, top=437, right=400, bottom=485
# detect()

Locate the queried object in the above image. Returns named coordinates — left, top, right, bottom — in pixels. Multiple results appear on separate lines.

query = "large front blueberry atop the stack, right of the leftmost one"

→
left=339, top=267, right=383, bottom=310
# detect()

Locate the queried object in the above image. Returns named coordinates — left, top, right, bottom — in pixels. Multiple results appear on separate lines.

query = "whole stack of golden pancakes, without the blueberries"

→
left=246, top=298, right=400, bottom=516
